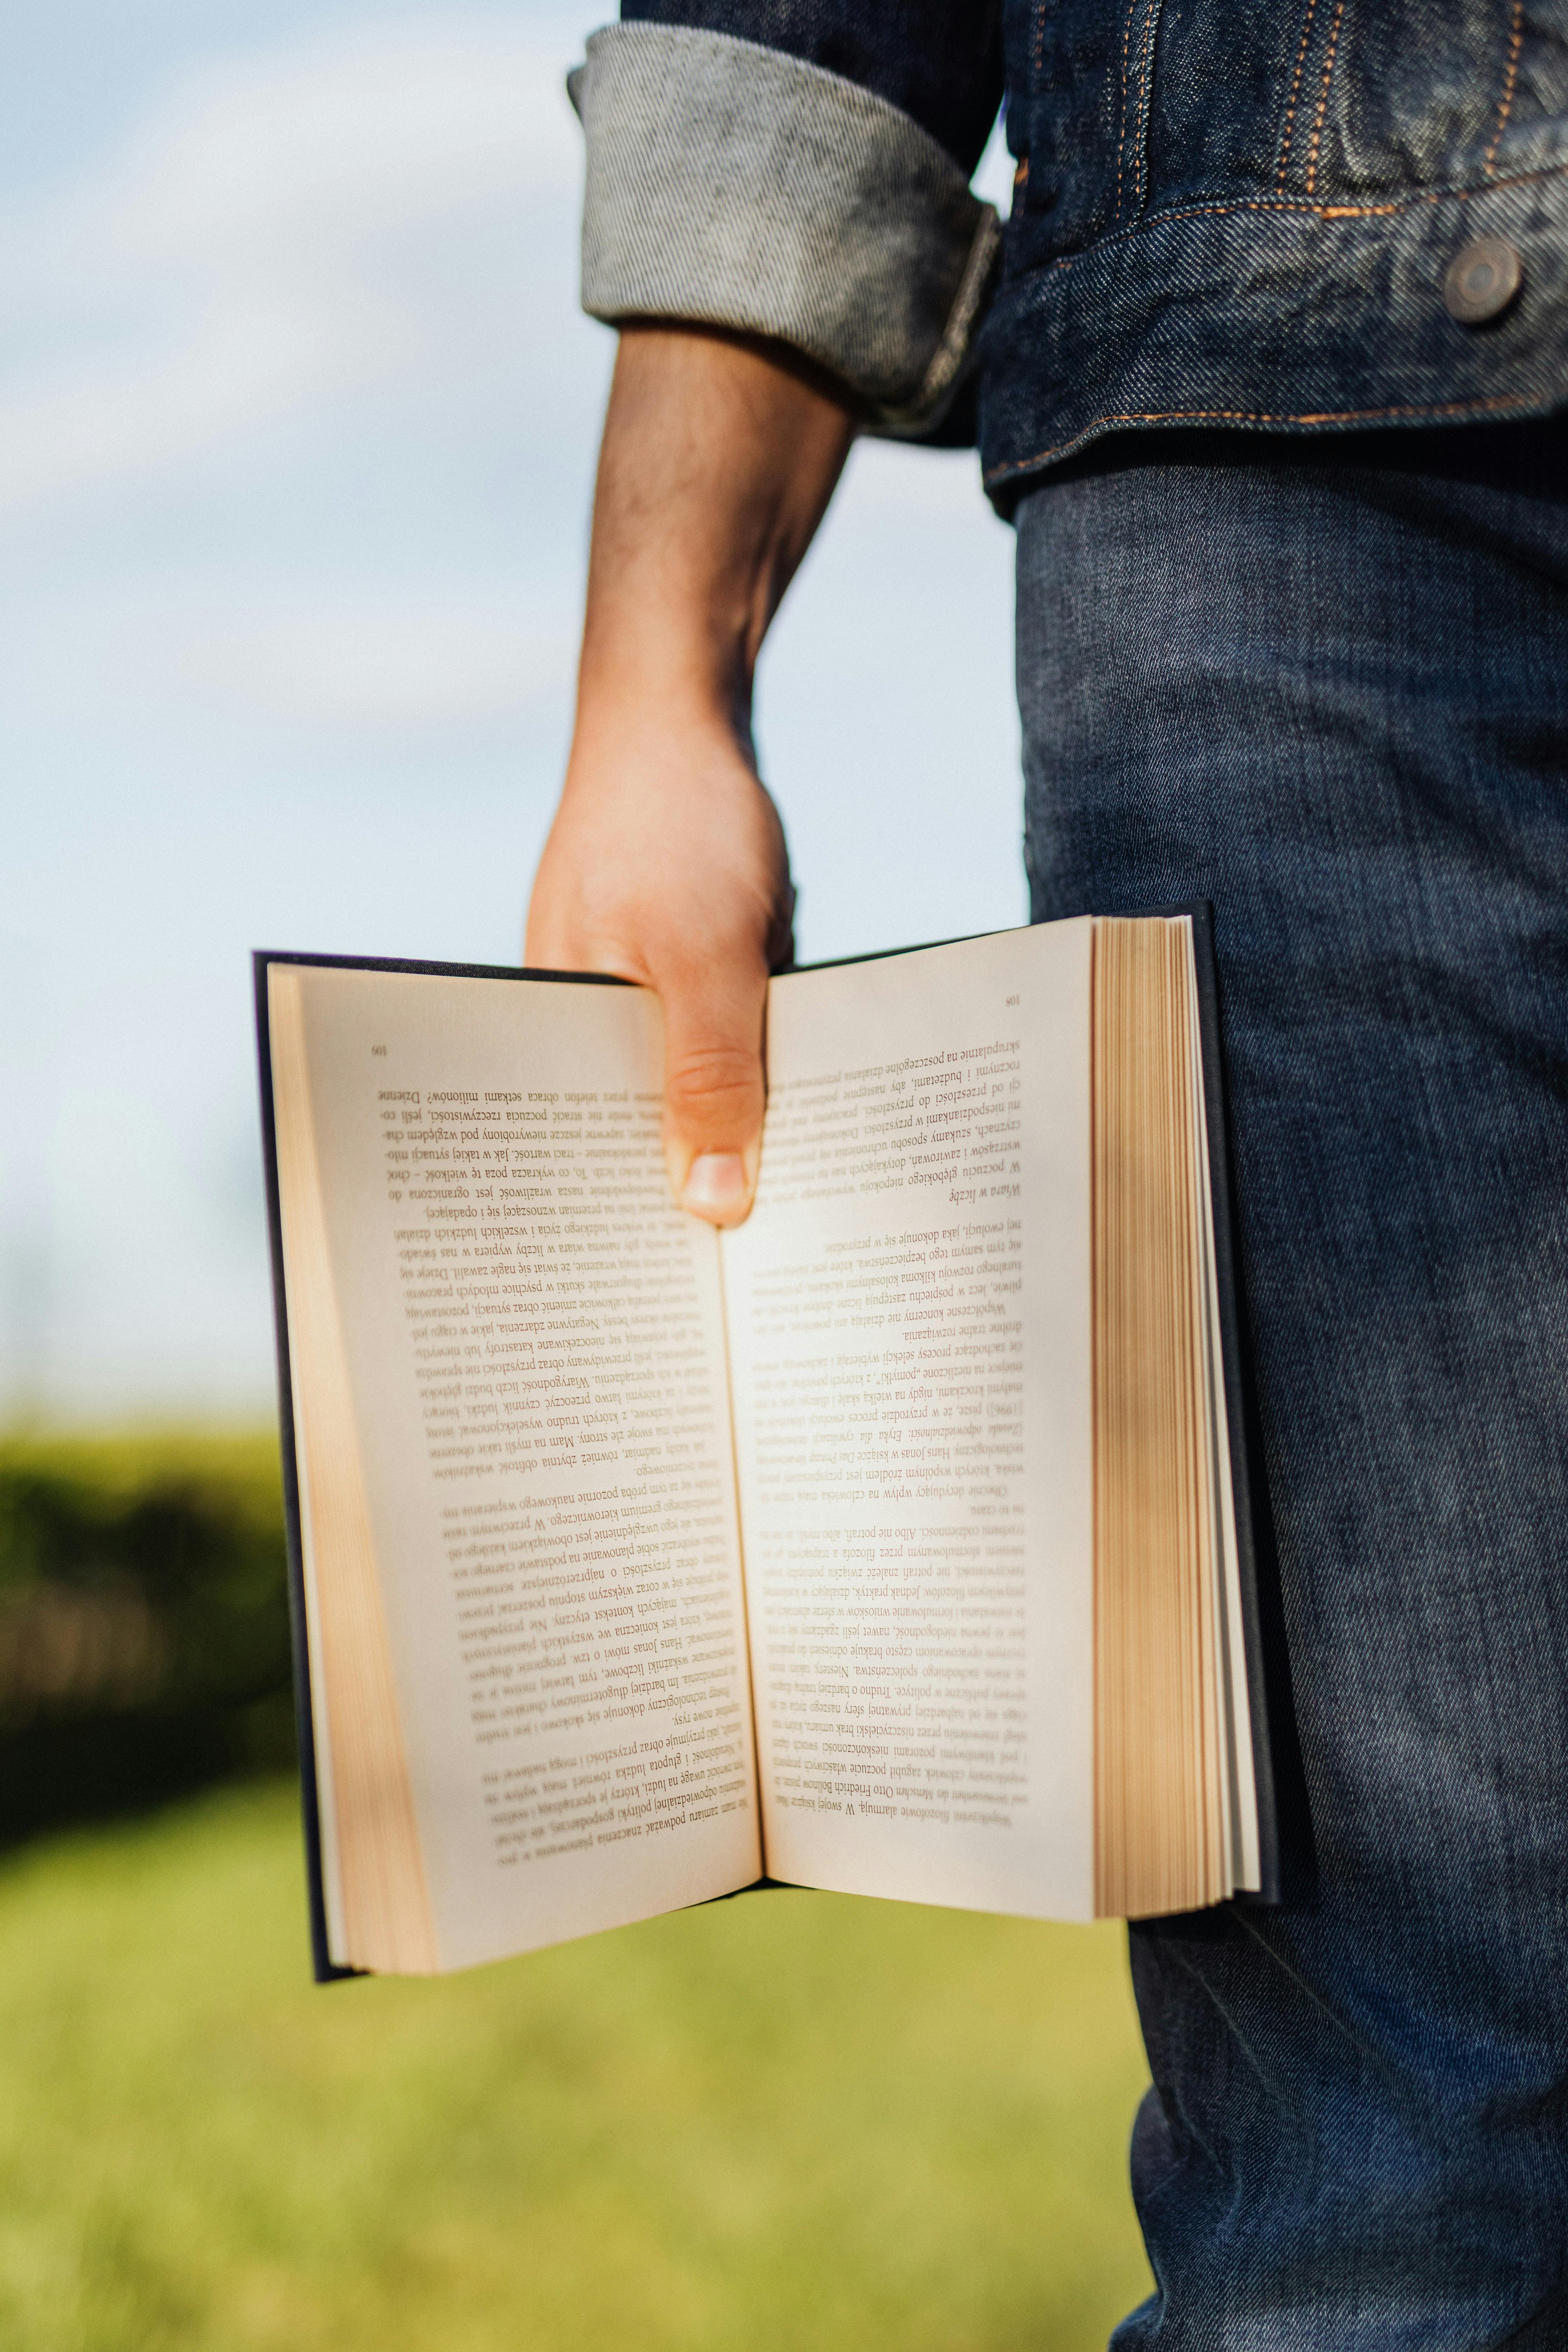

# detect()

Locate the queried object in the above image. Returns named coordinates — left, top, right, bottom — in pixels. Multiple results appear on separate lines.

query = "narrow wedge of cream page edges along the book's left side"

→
left=268, top=964, right=442, bottom=1976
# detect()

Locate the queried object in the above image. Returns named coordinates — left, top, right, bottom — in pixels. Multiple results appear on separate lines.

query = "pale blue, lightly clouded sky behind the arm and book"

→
left=0, top=0, right=1023, bottom=1421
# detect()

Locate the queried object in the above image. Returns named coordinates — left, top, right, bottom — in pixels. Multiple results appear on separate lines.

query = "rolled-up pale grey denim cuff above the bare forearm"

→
left=569, top=23, right=999, bottom=435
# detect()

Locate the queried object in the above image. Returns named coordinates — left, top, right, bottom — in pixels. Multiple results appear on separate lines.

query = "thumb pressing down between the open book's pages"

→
left=660, top=962, right=769, bottom=1225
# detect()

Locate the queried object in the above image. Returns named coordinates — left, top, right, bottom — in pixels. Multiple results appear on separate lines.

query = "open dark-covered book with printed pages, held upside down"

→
left=256, top=908, right=1272, bottom=1976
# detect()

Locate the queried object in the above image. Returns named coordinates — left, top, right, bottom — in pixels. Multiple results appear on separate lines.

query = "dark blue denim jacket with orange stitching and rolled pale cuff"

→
left=571, top=0, right=1568, bottom=506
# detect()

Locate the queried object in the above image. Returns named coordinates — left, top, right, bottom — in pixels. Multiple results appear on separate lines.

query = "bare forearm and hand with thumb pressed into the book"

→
left=527, top=327, right=853, bottom=1225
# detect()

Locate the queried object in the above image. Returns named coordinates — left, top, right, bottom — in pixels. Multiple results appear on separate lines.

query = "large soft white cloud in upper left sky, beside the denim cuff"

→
left=0, top=16, right=578, bottom=506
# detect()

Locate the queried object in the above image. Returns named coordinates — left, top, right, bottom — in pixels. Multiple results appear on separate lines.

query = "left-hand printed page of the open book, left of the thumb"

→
left=273, top=967, right=759, bottom=1969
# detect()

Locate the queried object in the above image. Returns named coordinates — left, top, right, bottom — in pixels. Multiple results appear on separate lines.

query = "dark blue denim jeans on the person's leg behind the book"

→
left=1018, top=426, right=1568, bottom=2352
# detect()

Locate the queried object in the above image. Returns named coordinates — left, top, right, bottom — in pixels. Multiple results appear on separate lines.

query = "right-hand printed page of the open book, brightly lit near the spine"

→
left=722, top=920, right=1093, bottom=1919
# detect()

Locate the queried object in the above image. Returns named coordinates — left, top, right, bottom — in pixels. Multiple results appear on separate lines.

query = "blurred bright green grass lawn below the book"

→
left=0, top=1787, right=1147, bottom=2352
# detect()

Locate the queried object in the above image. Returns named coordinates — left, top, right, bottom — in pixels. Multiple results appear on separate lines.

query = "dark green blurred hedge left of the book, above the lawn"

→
left=0, top=1435, right=294, bottom=1842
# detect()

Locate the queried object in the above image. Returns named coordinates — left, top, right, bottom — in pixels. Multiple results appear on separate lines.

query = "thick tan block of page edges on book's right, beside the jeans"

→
left=1091, top=920, right=1232, bottom=1917
